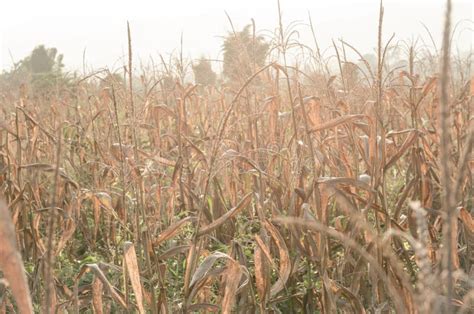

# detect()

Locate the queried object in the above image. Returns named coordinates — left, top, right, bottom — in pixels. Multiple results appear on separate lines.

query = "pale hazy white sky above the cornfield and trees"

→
left=0, top=0, right=474, bottom=69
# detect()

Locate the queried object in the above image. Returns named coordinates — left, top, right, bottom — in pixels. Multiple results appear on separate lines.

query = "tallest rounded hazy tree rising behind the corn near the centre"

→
left=223, top=25, right=269, bottom=81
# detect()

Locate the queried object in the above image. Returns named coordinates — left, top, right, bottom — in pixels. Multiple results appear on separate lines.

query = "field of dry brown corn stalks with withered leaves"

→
left=0, top=1, right=474, bottom=313
